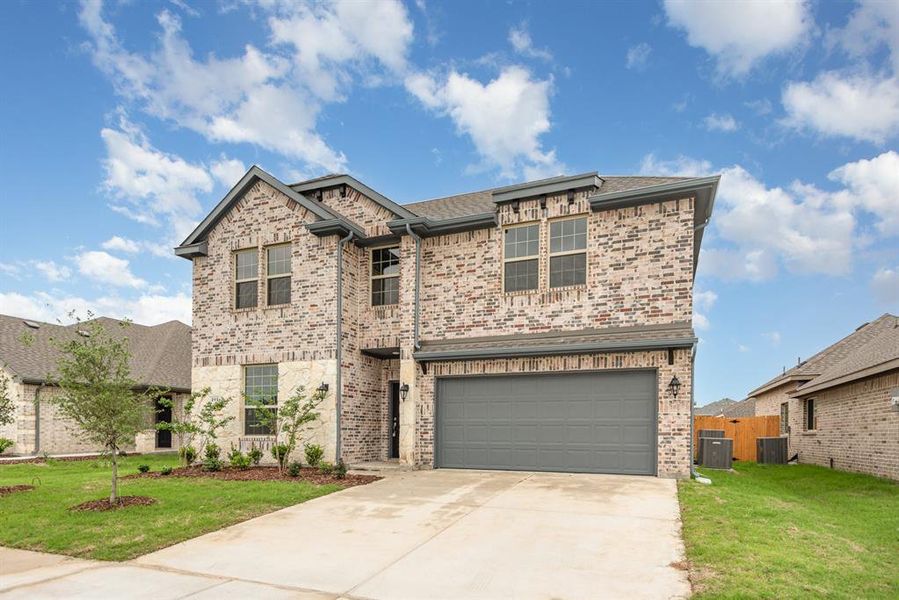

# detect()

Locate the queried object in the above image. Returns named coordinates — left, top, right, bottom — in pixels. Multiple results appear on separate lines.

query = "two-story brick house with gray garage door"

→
left=175, top=167, right=718, bottom=477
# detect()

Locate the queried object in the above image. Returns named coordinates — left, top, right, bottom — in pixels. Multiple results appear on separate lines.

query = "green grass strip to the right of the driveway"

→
left=679, top=463, right=899, bottom=598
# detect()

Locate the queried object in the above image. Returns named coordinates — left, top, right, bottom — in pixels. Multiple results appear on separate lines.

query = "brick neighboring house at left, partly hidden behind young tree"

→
left=0, top=315, right=190, bottom=454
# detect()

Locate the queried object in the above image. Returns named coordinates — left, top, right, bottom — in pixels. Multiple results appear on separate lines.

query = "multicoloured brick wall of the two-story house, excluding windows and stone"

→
left=186, top=176, right=693, bottom=477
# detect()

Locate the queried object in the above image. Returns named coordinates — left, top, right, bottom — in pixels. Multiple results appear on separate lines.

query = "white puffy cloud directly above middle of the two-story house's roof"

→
left=406, top=66, right=564, bottom=179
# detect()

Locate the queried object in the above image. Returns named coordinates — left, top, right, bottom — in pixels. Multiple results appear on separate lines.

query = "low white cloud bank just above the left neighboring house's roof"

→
left=0, top=292, right=191, bottom=325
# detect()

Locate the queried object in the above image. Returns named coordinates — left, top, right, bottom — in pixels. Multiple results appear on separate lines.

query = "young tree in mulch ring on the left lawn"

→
left=49, top=321, right=155, bottom=504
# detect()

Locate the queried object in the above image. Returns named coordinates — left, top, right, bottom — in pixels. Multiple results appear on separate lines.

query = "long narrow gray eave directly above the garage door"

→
left=412, top=337, right=697, bottom=362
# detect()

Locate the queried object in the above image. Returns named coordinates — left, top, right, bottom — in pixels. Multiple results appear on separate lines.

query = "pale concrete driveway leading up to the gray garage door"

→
left=1, top=470, right=690, bottom=600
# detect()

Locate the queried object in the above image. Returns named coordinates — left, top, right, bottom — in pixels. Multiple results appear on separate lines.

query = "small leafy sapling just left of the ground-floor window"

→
left=156, top=387, right=234, bottom=466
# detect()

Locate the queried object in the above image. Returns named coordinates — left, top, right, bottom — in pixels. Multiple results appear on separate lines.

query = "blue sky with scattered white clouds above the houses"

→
left=0, top=0, right=899, bottom=404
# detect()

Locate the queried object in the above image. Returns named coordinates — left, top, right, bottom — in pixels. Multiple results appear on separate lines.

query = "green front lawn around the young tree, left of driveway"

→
left=0, top=455, right=341, bottom=560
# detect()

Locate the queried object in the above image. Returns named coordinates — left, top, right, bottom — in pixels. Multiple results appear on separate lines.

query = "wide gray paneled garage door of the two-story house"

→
left=436, top=371, right=656, bottom=475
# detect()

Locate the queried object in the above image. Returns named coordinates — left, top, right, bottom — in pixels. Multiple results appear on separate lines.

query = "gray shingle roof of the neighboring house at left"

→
left=0, top=315, right=191, bottom=390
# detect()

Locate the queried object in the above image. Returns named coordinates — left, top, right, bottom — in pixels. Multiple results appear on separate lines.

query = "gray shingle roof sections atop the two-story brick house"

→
left=404, top=175, right=691, bottom=219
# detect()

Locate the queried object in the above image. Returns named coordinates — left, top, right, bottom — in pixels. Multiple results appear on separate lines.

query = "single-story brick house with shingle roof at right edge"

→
left=750, top=314, right=899, bottom=479
